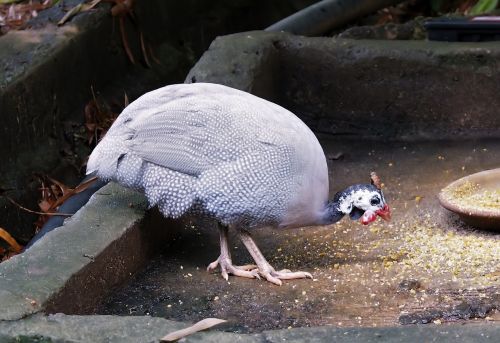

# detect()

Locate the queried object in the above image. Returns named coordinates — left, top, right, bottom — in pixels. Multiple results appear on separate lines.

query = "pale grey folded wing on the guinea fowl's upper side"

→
left=108, top=85, right=300, bottom=176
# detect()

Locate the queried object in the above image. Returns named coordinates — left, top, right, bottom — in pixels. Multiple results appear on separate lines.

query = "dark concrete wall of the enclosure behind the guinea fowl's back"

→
left=186, top=31, right=500, bottom=139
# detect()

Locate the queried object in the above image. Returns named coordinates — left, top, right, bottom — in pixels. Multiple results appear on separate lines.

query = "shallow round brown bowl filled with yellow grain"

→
left=438, top=168, right=500, bottom=231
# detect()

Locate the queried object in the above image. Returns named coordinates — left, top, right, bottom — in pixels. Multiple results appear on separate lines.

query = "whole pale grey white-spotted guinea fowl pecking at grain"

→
left=87, top=83, right=390, bottom=285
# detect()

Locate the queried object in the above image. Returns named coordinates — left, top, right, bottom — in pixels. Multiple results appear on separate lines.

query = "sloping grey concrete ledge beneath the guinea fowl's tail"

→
left=0, top=184, right=151, bottom=320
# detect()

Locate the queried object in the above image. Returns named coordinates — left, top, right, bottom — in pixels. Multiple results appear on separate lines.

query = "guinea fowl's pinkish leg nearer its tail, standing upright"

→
left=207, top=224, right=260, bottom=281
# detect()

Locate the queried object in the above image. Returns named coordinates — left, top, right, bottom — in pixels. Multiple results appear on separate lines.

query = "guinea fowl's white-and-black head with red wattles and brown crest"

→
left=334, top=173, right=391, bottom=225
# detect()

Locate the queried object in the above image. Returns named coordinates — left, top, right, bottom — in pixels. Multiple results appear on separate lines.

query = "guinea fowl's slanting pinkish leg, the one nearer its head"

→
left=238, top=230, right=312, bottom=286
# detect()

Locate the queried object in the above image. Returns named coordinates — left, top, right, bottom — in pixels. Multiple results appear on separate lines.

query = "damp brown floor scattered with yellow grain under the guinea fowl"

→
left=97, top=138, right=500, bottom=332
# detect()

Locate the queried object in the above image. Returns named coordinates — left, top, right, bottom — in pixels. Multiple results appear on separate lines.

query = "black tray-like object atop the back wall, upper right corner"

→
left=424, top=16, right=500, bottom=42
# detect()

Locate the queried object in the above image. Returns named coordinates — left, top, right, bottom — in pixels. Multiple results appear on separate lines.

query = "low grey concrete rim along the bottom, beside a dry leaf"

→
left=0, top=314, right=500, bottom=343
